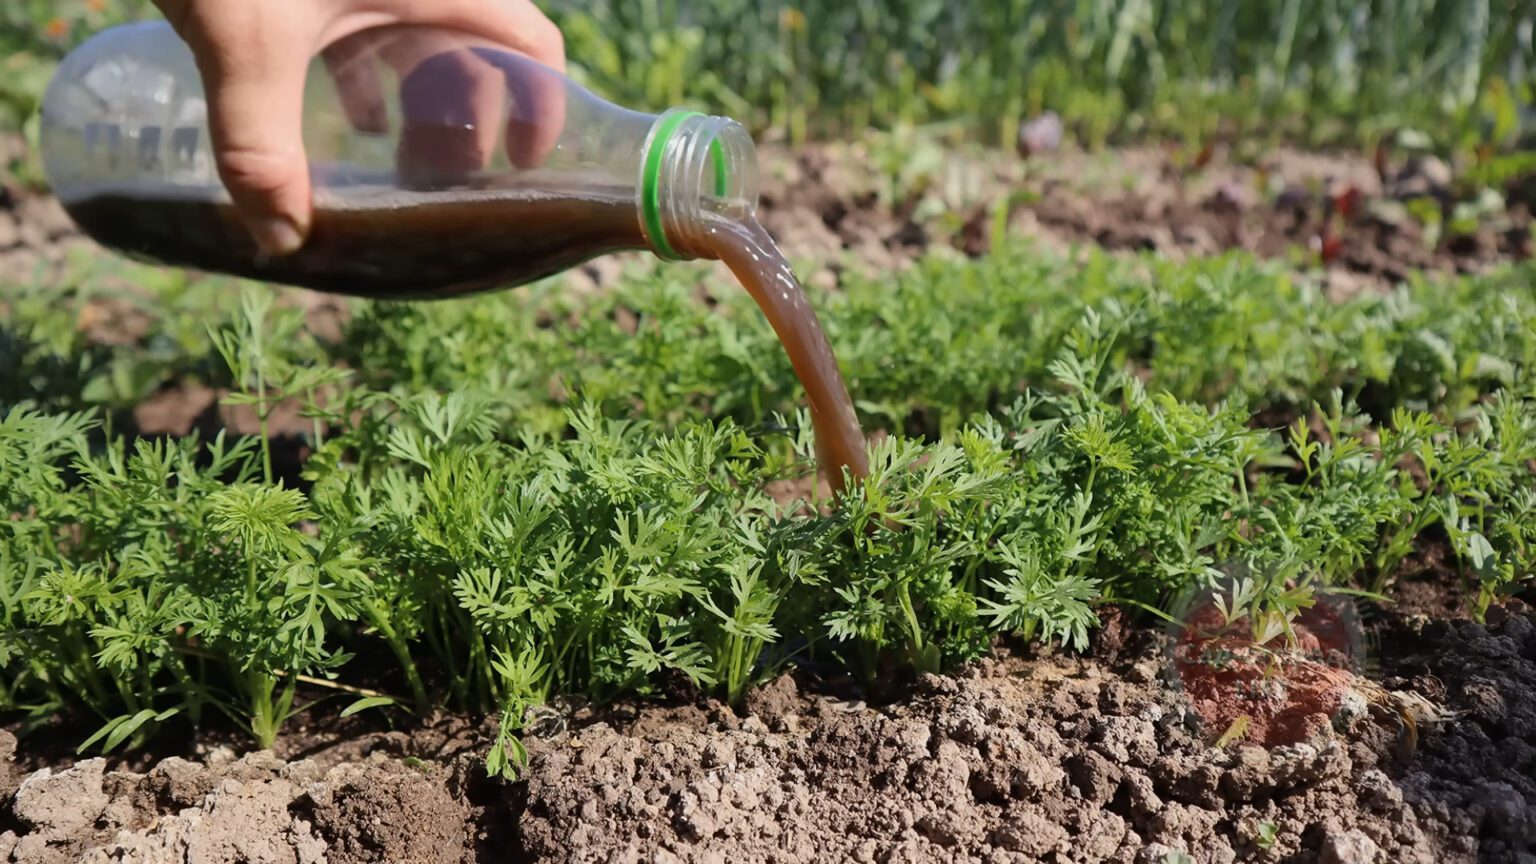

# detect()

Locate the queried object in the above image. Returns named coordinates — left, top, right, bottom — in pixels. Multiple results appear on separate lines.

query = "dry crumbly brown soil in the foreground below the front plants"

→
left=0, top=603, right=1536, bottom=864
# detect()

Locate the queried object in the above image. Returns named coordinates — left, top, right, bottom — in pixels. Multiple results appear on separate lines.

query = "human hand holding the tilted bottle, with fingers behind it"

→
left=155, top=0, right=565, bottom=255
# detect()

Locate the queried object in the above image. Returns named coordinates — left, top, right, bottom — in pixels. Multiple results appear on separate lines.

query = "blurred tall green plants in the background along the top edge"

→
left=0, top=0, right=1536, bottom=146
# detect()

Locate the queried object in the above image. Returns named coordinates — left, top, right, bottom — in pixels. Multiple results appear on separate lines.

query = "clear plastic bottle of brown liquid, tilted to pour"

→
left=41, top=22, right=757, bottom=298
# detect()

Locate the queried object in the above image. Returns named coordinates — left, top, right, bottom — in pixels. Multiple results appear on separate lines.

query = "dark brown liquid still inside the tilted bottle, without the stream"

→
left=65, top=191, right=645, bottom=300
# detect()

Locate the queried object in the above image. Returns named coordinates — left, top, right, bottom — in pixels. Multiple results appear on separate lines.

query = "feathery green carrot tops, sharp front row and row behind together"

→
left=0, top=239, right=1536, bottom=772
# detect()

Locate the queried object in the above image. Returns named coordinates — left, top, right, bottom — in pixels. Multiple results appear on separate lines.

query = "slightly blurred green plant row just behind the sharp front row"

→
left=14, top=241, right=1536, bottom=438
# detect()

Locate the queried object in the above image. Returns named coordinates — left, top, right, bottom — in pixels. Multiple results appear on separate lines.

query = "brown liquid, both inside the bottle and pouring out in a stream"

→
left=65, top=189, right=868, bottom=490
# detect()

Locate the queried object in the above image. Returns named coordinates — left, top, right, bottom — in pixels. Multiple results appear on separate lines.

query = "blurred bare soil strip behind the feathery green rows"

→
left=0, top=141, right=1536, bottom=307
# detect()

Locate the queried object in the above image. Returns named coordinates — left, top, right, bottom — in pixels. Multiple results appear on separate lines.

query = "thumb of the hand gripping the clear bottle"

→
left=186, top=12, right=312, bottom=255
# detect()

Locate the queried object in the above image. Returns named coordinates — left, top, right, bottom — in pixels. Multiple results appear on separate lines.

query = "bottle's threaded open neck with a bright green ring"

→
left=639, top=109, right=757, bottom=261
